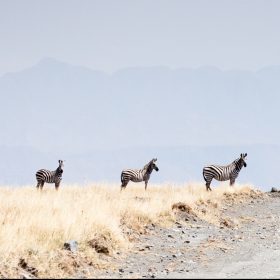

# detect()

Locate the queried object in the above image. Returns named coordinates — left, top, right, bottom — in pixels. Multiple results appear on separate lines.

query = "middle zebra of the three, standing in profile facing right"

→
left=121, top=158, right=159, bottom=190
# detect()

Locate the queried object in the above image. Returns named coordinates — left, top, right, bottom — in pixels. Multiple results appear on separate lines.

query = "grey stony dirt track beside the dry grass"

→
left=95, top=193, right=280, bottom=278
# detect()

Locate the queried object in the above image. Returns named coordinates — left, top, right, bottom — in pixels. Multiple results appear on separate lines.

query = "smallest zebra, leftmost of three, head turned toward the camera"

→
left=36, top=160, right=64, bottom=190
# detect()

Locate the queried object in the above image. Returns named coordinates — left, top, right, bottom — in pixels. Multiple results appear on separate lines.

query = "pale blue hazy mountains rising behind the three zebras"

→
left=0, top=58, right=280, bottom=189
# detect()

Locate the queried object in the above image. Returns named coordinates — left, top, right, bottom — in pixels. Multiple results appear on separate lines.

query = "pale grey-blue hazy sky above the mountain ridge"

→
left=0, top=0, right=280, bottom=75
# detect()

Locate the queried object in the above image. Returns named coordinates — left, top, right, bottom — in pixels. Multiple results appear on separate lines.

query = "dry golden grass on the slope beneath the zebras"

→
left=0, top=183, right=260, bottom=277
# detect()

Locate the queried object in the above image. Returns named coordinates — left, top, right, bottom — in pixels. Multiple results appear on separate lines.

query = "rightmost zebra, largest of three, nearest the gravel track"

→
left=203, top=153, right=247, bottom=191
